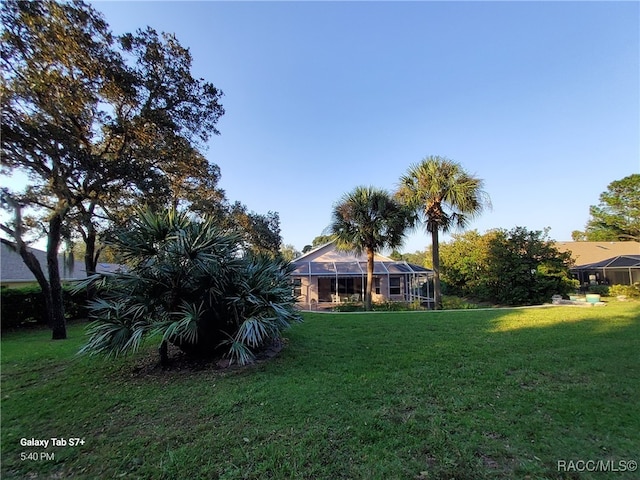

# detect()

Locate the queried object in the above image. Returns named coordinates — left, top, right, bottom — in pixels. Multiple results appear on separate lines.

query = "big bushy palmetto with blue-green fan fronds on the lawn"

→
left=82, top=210, right=301, bottom=364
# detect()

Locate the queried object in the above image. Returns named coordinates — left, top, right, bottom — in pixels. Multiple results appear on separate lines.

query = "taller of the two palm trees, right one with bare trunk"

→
left=396, top=156, right=491, bottom=309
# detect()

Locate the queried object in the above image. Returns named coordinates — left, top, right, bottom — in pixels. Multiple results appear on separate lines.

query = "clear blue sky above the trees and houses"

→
left=92, top=1, right=640, bottom=252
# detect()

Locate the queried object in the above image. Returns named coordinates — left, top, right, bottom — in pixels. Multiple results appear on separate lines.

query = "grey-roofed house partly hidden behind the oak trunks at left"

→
left=0, top=243, right=120, bottom=287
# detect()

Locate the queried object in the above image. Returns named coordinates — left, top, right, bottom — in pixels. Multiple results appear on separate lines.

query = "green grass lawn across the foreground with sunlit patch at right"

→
left=0, top=301, right=640, bottom=480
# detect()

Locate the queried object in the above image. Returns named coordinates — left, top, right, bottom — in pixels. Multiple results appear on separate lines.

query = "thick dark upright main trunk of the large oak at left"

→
left=43, top=214, right=67, bottom=340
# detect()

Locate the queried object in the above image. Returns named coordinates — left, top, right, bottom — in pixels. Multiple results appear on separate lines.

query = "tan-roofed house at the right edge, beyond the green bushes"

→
left=556, top=242, right=640, bottom=286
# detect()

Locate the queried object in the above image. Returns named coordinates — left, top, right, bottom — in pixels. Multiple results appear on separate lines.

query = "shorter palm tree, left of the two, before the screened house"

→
left=329, top=186, right=414, bottom=310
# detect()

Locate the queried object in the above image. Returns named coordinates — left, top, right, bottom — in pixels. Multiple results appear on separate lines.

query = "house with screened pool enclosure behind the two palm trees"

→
left=291, top=242, right=433, bottom=308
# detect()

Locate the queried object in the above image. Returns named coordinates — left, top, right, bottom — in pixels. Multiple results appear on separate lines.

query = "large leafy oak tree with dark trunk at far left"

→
left=0, top=0, right=224, bottom=339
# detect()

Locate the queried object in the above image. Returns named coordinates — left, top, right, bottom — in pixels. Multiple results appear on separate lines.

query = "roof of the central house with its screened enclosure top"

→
left=291, top=242, right=432, bottom=276
